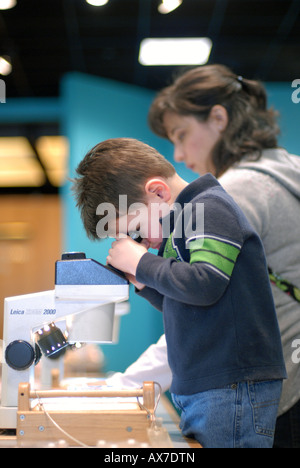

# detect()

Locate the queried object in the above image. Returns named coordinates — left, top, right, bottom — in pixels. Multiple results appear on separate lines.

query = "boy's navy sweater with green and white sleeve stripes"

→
left=136, top=175, right=286, bottom=395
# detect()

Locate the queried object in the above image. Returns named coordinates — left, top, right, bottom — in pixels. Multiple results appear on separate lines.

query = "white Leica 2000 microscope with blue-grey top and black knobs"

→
left=0, top=252, right=129, bottom=429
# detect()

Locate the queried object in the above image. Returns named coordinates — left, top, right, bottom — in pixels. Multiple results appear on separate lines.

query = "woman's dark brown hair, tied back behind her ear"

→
left=149, top=65, right=279, bottom=176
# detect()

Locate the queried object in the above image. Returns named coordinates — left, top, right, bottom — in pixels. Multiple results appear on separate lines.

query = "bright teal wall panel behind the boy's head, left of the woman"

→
left=62, top=73, right=177, bottom=371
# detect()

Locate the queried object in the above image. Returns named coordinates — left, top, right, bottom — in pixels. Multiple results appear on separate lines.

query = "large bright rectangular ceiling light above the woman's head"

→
left=139, top=37, right=212, bottom=66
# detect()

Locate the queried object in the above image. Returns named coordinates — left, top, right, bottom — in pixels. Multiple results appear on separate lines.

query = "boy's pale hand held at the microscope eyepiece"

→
left=106, top=236, right=148, bottom=282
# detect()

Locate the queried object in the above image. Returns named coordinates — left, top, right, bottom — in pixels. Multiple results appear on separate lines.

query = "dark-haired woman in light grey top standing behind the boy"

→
left=108, top=65, right=300, bottom=447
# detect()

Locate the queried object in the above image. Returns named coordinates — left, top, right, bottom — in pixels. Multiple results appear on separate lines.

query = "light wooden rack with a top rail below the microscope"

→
left=17, top=382, right=155, bottom=447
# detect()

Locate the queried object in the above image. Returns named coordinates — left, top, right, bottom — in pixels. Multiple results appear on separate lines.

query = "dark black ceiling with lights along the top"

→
left=0, top=0, right=300, bottom=98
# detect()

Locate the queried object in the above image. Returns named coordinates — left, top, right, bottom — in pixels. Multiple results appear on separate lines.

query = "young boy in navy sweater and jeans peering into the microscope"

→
left=74, top=138, right=286, bottom=448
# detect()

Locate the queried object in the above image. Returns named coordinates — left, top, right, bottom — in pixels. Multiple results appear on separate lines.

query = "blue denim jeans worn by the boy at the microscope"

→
left=172, top=380, right=282, bottom=448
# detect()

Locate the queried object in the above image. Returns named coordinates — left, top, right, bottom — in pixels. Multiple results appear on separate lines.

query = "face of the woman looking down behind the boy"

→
left=164, top=111, right=221, bottom=175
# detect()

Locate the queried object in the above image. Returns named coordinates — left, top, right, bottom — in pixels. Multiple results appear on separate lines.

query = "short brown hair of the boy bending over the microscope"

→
left=72, top=138, right=175, bottom=240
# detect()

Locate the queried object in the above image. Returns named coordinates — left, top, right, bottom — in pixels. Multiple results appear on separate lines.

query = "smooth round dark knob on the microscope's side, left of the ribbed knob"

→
left=5, top=340, right=36, bottom=371
